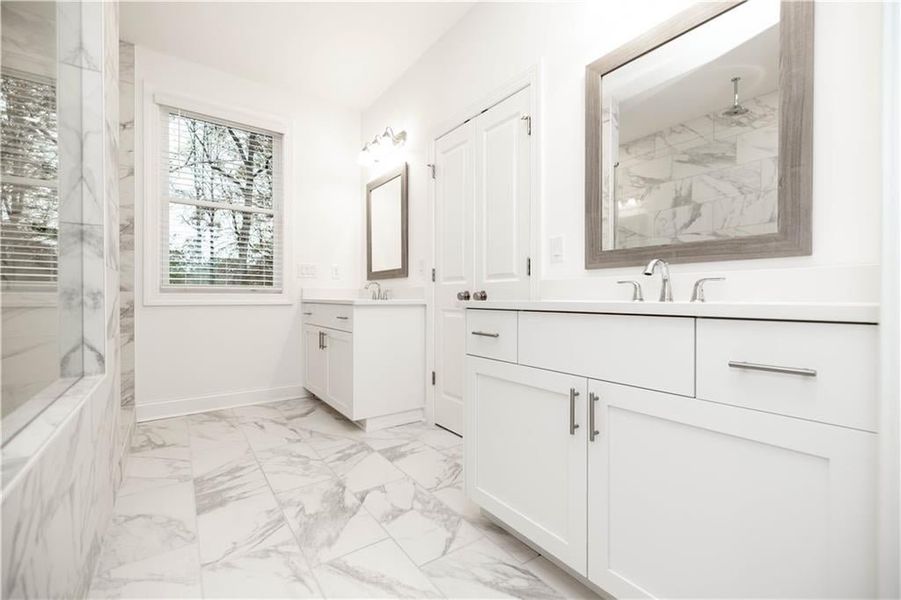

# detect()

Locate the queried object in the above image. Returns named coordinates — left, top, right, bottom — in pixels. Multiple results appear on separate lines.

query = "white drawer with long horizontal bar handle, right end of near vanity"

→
left=698, top=319, right=878, bottom=431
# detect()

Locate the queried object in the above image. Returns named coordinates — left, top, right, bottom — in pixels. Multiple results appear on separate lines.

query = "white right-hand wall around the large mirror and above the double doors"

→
left=361, top=0, right=882, bottom=302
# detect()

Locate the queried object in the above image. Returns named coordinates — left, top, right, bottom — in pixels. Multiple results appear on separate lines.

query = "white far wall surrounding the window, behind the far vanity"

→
left=135, top=47, right=361, bottom=419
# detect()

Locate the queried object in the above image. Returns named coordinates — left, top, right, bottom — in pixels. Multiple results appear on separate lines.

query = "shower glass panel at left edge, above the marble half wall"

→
left=0, top=0, right=83, bottom=444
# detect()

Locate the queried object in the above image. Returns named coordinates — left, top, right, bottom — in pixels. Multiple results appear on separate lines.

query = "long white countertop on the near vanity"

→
left=459, top=300, right=879, bottom=323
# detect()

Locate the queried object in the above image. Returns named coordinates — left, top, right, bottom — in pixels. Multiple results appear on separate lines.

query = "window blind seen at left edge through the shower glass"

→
left=0, top=70, right=59, bottom=290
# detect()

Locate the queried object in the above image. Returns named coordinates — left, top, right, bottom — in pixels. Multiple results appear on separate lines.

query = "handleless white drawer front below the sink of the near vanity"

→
left=519, top=312, right=695, bottom=396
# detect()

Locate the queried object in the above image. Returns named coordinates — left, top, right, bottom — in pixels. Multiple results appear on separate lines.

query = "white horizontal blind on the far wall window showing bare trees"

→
left=160, top=107, right=283, bottom=292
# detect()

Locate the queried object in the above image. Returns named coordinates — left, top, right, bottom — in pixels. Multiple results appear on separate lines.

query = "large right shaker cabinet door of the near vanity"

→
left=588, top=381, right=876, bottom=598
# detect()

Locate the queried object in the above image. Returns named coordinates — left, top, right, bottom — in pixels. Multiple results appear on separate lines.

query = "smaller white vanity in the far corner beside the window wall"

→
left=301, top=298, right=426, bottom=431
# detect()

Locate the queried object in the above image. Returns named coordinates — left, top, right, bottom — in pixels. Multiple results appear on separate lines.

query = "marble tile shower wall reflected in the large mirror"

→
left=616, top=91, right=779, bottom=248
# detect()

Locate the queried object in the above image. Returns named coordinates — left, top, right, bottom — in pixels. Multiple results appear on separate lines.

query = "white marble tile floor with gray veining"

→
left=89, top=399, right=594, bottom=598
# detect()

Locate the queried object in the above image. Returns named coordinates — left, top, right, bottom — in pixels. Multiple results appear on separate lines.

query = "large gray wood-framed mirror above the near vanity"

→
left=585, top=0, right=814, bottom=269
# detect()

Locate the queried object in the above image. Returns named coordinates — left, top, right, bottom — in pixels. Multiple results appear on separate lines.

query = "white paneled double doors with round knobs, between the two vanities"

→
left=434, top=88, right=531, bottom=434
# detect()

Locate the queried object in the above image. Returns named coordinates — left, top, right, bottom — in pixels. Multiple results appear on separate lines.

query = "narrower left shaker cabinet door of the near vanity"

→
left=464, top=356, right=587, bottom=575
